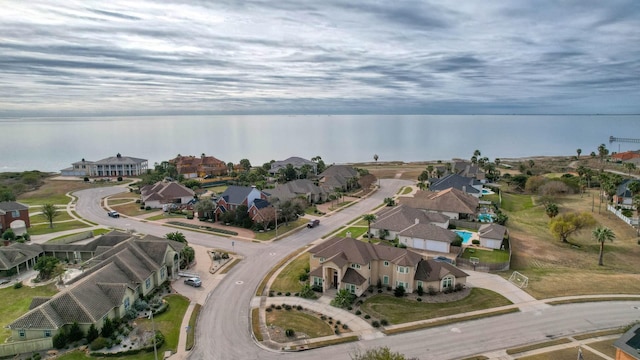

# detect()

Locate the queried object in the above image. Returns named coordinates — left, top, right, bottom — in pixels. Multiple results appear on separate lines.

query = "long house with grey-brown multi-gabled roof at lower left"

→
left=7, top=232, right=184, bottom=341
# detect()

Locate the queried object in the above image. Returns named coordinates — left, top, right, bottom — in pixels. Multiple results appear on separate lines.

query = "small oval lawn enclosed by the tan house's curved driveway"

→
left=267, top=308, right=333, bottom=338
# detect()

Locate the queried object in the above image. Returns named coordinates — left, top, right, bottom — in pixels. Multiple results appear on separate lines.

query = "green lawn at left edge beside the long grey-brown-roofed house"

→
left=0, top=285, right=58, bottom=343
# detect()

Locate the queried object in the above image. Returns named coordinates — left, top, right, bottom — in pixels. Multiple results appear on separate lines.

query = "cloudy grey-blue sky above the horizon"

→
left=0, top=0, right=640, bottom=117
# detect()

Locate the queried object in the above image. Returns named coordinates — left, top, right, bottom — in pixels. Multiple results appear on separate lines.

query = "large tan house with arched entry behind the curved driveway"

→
left=309, top=238, right=468, bottom=296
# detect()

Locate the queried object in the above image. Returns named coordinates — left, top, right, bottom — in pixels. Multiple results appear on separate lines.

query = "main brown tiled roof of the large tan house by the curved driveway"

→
left=309, top=238, right=422, bottom=266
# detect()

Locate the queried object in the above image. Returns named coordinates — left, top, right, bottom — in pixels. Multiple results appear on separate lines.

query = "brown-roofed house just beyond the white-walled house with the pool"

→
left=398, top=188, right=480, bottom=219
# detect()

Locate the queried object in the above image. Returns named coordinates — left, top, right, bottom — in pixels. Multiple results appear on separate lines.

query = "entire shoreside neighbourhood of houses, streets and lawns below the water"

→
left=0, top=144, right=640, bottom=360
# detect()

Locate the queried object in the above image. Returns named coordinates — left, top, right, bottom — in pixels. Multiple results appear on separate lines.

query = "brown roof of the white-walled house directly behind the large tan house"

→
left=371, top=205, right=449, bottom=231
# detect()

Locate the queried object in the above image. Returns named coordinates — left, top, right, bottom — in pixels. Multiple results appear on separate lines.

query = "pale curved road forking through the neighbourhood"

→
left=75, top=179, right=640, bottom=360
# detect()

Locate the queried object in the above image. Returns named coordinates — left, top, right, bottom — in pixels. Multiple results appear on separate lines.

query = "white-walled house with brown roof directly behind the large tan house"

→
left=371, top=205, right=449, bottom=239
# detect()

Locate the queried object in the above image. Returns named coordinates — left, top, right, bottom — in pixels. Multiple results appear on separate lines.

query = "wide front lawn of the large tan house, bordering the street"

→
left=360, top=288, right=512, bottom=324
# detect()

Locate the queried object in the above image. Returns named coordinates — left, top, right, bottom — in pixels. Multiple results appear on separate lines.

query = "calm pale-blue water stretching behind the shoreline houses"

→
left=0, top=115, right=640, bottom=172
